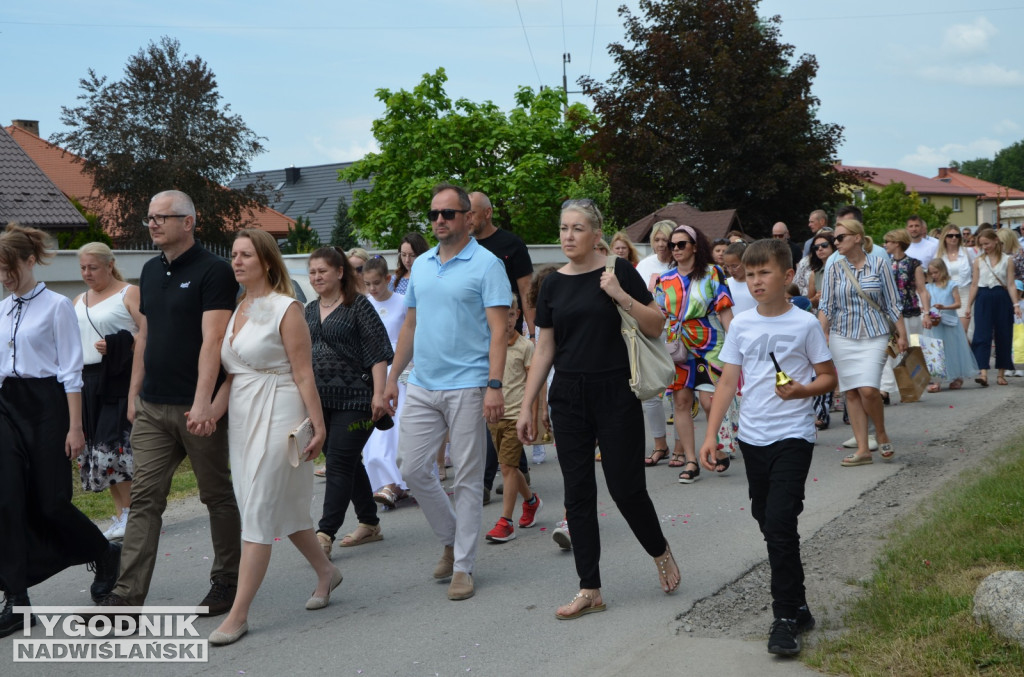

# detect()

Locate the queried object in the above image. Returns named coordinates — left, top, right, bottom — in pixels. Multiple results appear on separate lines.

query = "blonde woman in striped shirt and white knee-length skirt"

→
left=818, top=218, right=907, bottom=467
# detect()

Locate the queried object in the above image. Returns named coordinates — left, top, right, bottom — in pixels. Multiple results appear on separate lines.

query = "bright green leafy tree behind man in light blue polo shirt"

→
left=339, top=69, right=596, bottom=248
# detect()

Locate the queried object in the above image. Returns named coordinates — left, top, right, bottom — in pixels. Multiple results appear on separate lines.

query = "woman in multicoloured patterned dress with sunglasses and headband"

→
left=654, top=225, right=732, bottom=484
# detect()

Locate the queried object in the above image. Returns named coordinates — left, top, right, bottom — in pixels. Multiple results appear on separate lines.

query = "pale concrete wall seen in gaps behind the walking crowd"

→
left=14, top=240, right=650, bottom=298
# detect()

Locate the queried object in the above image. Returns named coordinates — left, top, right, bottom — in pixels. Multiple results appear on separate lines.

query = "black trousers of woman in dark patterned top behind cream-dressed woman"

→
left=316, top=409, right=380, bottom=538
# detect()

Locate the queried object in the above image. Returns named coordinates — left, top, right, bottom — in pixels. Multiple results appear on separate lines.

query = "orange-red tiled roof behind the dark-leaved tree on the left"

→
left=4, top=120, right=295, bottom=240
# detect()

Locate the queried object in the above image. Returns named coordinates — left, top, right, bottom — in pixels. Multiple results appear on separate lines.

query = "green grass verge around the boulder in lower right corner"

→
left=804, top=436, right=1024, bottom=677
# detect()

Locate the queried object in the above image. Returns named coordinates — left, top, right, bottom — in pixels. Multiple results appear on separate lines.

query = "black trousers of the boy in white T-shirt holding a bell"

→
left=739, top=438, right=814, bottom=619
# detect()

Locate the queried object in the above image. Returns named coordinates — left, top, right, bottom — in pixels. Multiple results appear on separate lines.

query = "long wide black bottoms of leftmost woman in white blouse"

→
left=0, top=377, right=108, bottom=594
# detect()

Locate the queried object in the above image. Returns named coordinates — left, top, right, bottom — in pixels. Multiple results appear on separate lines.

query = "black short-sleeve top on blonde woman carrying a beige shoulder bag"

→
left=537, top=258, right=654, bottom=374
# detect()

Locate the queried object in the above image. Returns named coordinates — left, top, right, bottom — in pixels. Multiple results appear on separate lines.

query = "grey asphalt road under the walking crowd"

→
left=8, top=379, right=1024, bottom=677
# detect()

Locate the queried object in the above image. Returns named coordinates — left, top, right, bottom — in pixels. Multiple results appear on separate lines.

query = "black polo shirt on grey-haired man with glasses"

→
left=138, top=242, right=239, bottom=405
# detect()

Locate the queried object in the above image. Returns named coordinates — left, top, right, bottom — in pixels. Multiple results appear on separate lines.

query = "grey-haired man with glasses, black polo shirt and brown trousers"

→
left=100, top=191, right=242, bottom=616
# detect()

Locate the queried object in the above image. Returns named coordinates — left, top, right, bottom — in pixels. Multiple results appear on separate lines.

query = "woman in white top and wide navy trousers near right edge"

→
left=968, top=228, right=1021, bottom=388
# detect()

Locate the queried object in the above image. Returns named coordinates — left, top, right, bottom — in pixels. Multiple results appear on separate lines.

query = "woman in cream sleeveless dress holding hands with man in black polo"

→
left=210, top=229, right=342, bottom=645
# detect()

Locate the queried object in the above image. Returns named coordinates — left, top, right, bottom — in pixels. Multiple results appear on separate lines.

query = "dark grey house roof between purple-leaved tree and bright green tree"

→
left=227, top=162, right=371, bottom=242
